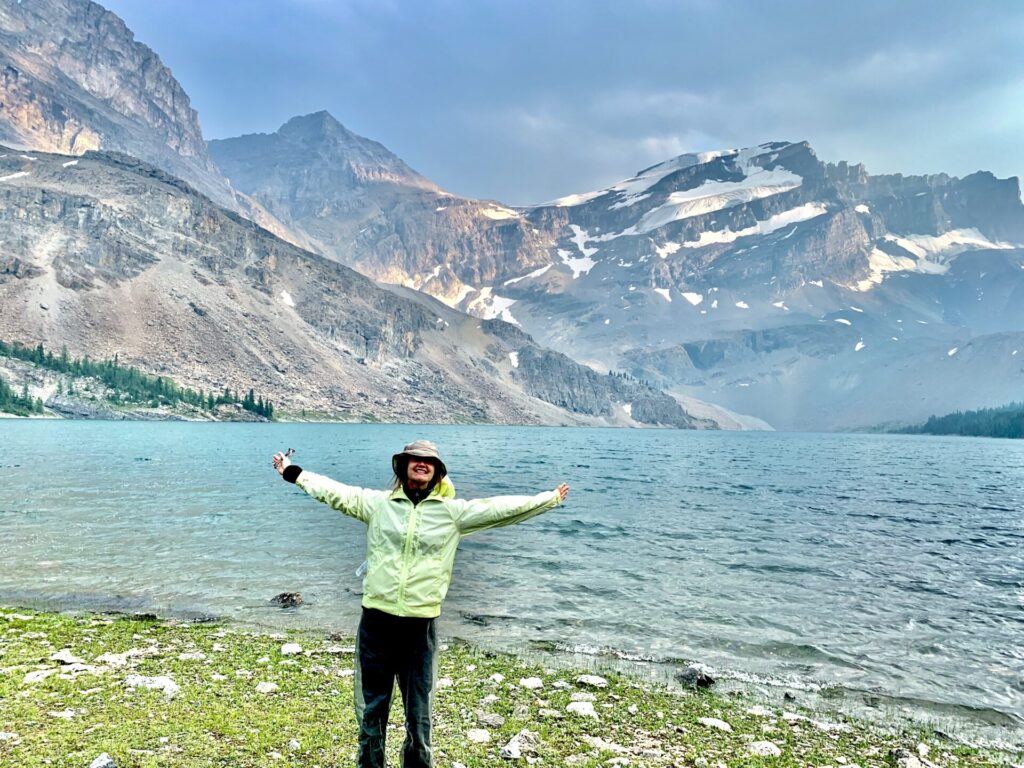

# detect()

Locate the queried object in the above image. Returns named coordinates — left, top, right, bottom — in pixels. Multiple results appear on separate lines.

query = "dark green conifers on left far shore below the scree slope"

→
left=0, top=340, right=273, bottom=419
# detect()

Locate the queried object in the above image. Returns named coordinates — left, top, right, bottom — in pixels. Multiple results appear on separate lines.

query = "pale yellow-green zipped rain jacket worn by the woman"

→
left=295, top=470, right=561, bottom=618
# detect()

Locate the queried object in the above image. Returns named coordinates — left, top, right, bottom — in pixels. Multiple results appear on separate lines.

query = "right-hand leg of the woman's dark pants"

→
left=398, top=618, right=437, bottom=768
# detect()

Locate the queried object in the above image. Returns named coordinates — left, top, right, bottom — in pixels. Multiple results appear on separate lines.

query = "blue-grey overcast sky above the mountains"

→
left=101, top=0, right=1024, bottom=205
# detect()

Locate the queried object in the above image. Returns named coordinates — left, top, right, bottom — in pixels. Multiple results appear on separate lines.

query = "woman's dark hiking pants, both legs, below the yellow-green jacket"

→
left=353, top=608, right=437, bottom=768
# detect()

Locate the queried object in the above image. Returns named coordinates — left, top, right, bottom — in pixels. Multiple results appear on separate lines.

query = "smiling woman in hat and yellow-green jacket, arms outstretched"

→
left=273, top=440, right=569, bottom=768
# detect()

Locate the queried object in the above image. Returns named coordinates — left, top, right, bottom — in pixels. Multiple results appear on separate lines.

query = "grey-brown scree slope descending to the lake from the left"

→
left=0, top=147, right=696, bottom=426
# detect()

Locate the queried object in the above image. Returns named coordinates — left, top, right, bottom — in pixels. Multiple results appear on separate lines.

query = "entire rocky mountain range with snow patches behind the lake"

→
left=0, top=0, right=1024, bottom=430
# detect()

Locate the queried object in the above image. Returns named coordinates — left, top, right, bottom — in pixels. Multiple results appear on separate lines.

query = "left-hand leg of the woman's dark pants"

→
left=352, top=610, right=396, bottom=768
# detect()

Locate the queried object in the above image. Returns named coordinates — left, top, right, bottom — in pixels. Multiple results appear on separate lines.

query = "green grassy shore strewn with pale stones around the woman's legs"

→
left=0, top=608, right=1024, bottom=768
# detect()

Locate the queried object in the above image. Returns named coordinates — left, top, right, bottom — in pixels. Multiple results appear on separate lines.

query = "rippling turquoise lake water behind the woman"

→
left=0, top=420, right=1024, bottom=744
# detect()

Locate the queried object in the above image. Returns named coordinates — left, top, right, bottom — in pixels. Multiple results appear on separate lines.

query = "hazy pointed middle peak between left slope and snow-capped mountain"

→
left=210, top=112, right=551, bottom=304
